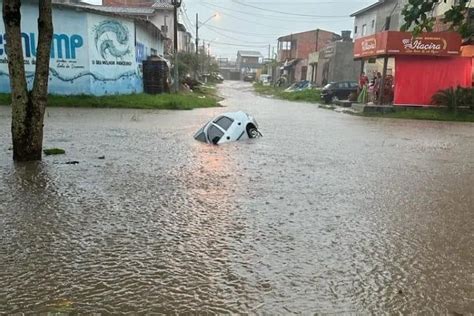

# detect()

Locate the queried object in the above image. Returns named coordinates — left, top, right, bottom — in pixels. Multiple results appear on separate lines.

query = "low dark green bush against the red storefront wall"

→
left=432, top=86, right=474, bottom=111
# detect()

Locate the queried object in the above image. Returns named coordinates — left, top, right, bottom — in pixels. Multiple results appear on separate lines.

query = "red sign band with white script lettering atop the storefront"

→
left=354, top=31, right=461, bottom=59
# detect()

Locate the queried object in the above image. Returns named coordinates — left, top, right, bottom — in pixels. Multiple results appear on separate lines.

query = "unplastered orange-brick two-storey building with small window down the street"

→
left=277, top=29, right=341, bottom=82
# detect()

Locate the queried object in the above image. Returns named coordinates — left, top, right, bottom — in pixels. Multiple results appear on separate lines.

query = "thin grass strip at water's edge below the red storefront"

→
left=358, top=108, right=474, bottom=122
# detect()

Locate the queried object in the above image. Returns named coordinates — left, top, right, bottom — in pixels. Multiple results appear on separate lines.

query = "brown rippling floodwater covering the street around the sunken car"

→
left=0, top=82, right=474, bottom=315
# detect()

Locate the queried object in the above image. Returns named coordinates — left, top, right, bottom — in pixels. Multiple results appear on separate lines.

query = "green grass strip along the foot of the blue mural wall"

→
left=0, top=87, right=220, bottom=110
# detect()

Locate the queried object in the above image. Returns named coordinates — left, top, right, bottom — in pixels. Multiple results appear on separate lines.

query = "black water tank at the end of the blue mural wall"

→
left=143, top=56, right=169, bottom=94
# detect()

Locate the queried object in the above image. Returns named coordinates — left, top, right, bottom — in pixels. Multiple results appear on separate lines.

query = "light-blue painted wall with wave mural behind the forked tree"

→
left=0, top=1, right=164, bottom=95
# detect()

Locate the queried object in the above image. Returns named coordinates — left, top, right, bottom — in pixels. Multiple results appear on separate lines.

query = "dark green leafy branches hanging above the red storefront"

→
left=402, top=0, right=474, bottom=38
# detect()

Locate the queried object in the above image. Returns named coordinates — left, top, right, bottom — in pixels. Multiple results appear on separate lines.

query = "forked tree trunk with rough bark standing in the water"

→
left=3, top=0, right=53, bottom=161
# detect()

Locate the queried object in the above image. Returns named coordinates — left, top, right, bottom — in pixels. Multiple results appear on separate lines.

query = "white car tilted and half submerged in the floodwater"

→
left=194, top=111, right=262, bottom=145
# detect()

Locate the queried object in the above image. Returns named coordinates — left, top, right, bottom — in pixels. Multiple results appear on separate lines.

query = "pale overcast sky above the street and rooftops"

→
left=85, top=0, right=375, bottom=59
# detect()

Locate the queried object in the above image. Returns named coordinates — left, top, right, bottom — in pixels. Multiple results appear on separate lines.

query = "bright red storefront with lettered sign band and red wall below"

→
left=354, top=31, right=473, bottom=106
